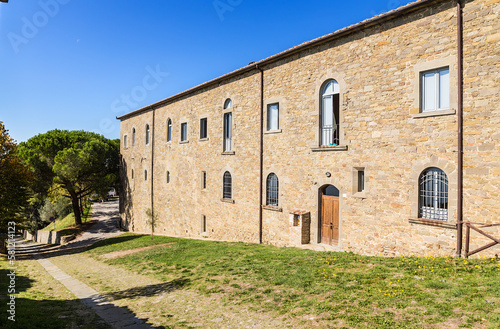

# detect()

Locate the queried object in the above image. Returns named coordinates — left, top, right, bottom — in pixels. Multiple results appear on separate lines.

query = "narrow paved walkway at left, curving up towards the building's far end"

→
left=16, top=202, right=152, bottom=329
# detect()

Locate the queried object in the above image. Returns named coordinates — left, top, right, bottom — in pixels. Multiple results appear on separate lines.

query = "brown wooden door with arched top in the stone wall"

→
left=319, top=185, right=340, bottom=245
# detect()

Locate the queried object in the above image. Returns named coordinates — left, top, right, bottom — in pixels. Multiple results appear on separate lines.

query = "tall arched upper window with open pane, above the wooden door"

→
left=320, top=80, right=340, bottom=146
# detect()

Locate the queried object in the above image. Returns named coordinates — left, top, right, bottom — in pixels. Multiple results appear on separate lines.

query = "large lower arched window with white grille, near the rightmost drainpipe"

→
left=418, top=168, right=448, bottom=220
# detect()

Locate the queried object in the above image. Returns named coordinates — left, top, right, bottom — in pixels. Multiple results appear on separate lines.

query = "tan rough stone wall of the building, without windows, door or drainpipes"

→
left=121, top=0, right=500, bottom=255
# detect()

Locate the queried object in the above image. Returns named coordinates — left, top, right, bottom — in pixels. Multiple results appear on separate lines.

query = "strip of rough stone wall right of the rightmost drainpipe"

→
left=463, top=0, right=500, bottom=255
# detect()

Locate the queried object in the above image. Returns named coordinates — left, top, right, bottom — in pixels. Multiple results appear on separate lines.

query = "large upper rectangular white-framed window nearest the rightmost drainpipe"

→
left=421, top=68, right=450, bottom=112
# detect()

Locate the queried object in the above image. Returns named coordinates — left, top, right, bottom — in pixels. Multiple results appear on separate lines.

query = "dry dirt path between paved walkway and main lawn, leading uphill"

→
left=20, top=202, right=296, bottom=329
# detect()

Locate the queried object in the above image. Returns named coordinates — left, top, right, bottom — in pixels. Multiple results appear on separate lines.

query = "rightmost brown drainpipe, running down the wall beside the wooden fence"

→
left=457, top=0, right=464, bottom=257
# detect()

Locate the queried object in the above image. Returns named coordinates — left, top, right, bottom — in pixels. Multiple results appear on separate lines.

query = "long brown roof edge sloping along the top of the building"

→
left=116, top=0, right=444, bottom=120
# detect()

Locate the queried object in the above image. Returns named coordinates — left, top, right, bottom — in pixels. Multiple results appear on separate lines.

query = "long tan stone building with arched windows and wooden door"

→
left=118, top=0, right=500, bottom=255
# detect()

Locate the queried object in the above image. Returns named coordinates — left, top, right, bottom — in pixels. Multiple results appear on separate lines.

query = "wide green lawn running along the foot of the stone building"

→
left=86, top=234, right=500, bottom=328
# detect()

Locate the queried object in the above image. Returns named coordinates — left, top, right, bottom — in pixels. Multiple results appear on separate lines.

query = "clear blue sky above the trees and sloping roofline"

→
left=0, top=0, right=412, bottom=142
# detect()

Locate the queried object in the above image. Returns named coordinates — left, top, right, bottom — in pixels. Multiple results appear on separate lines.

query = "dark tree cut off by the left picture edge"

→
left=0, top=122, right=32, bottom=232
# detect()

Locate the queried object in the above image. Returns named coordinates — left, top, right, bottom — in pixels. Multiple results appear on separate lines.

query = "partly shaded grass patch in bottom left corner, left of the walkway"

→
left=0, top=257, right=110, bottom=329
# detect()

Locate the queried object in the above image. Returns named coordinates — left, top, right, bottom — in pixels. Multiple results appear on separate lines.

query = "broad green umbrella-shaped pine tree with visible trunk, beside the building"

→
left=19, top=129, right=120, bottom=225
